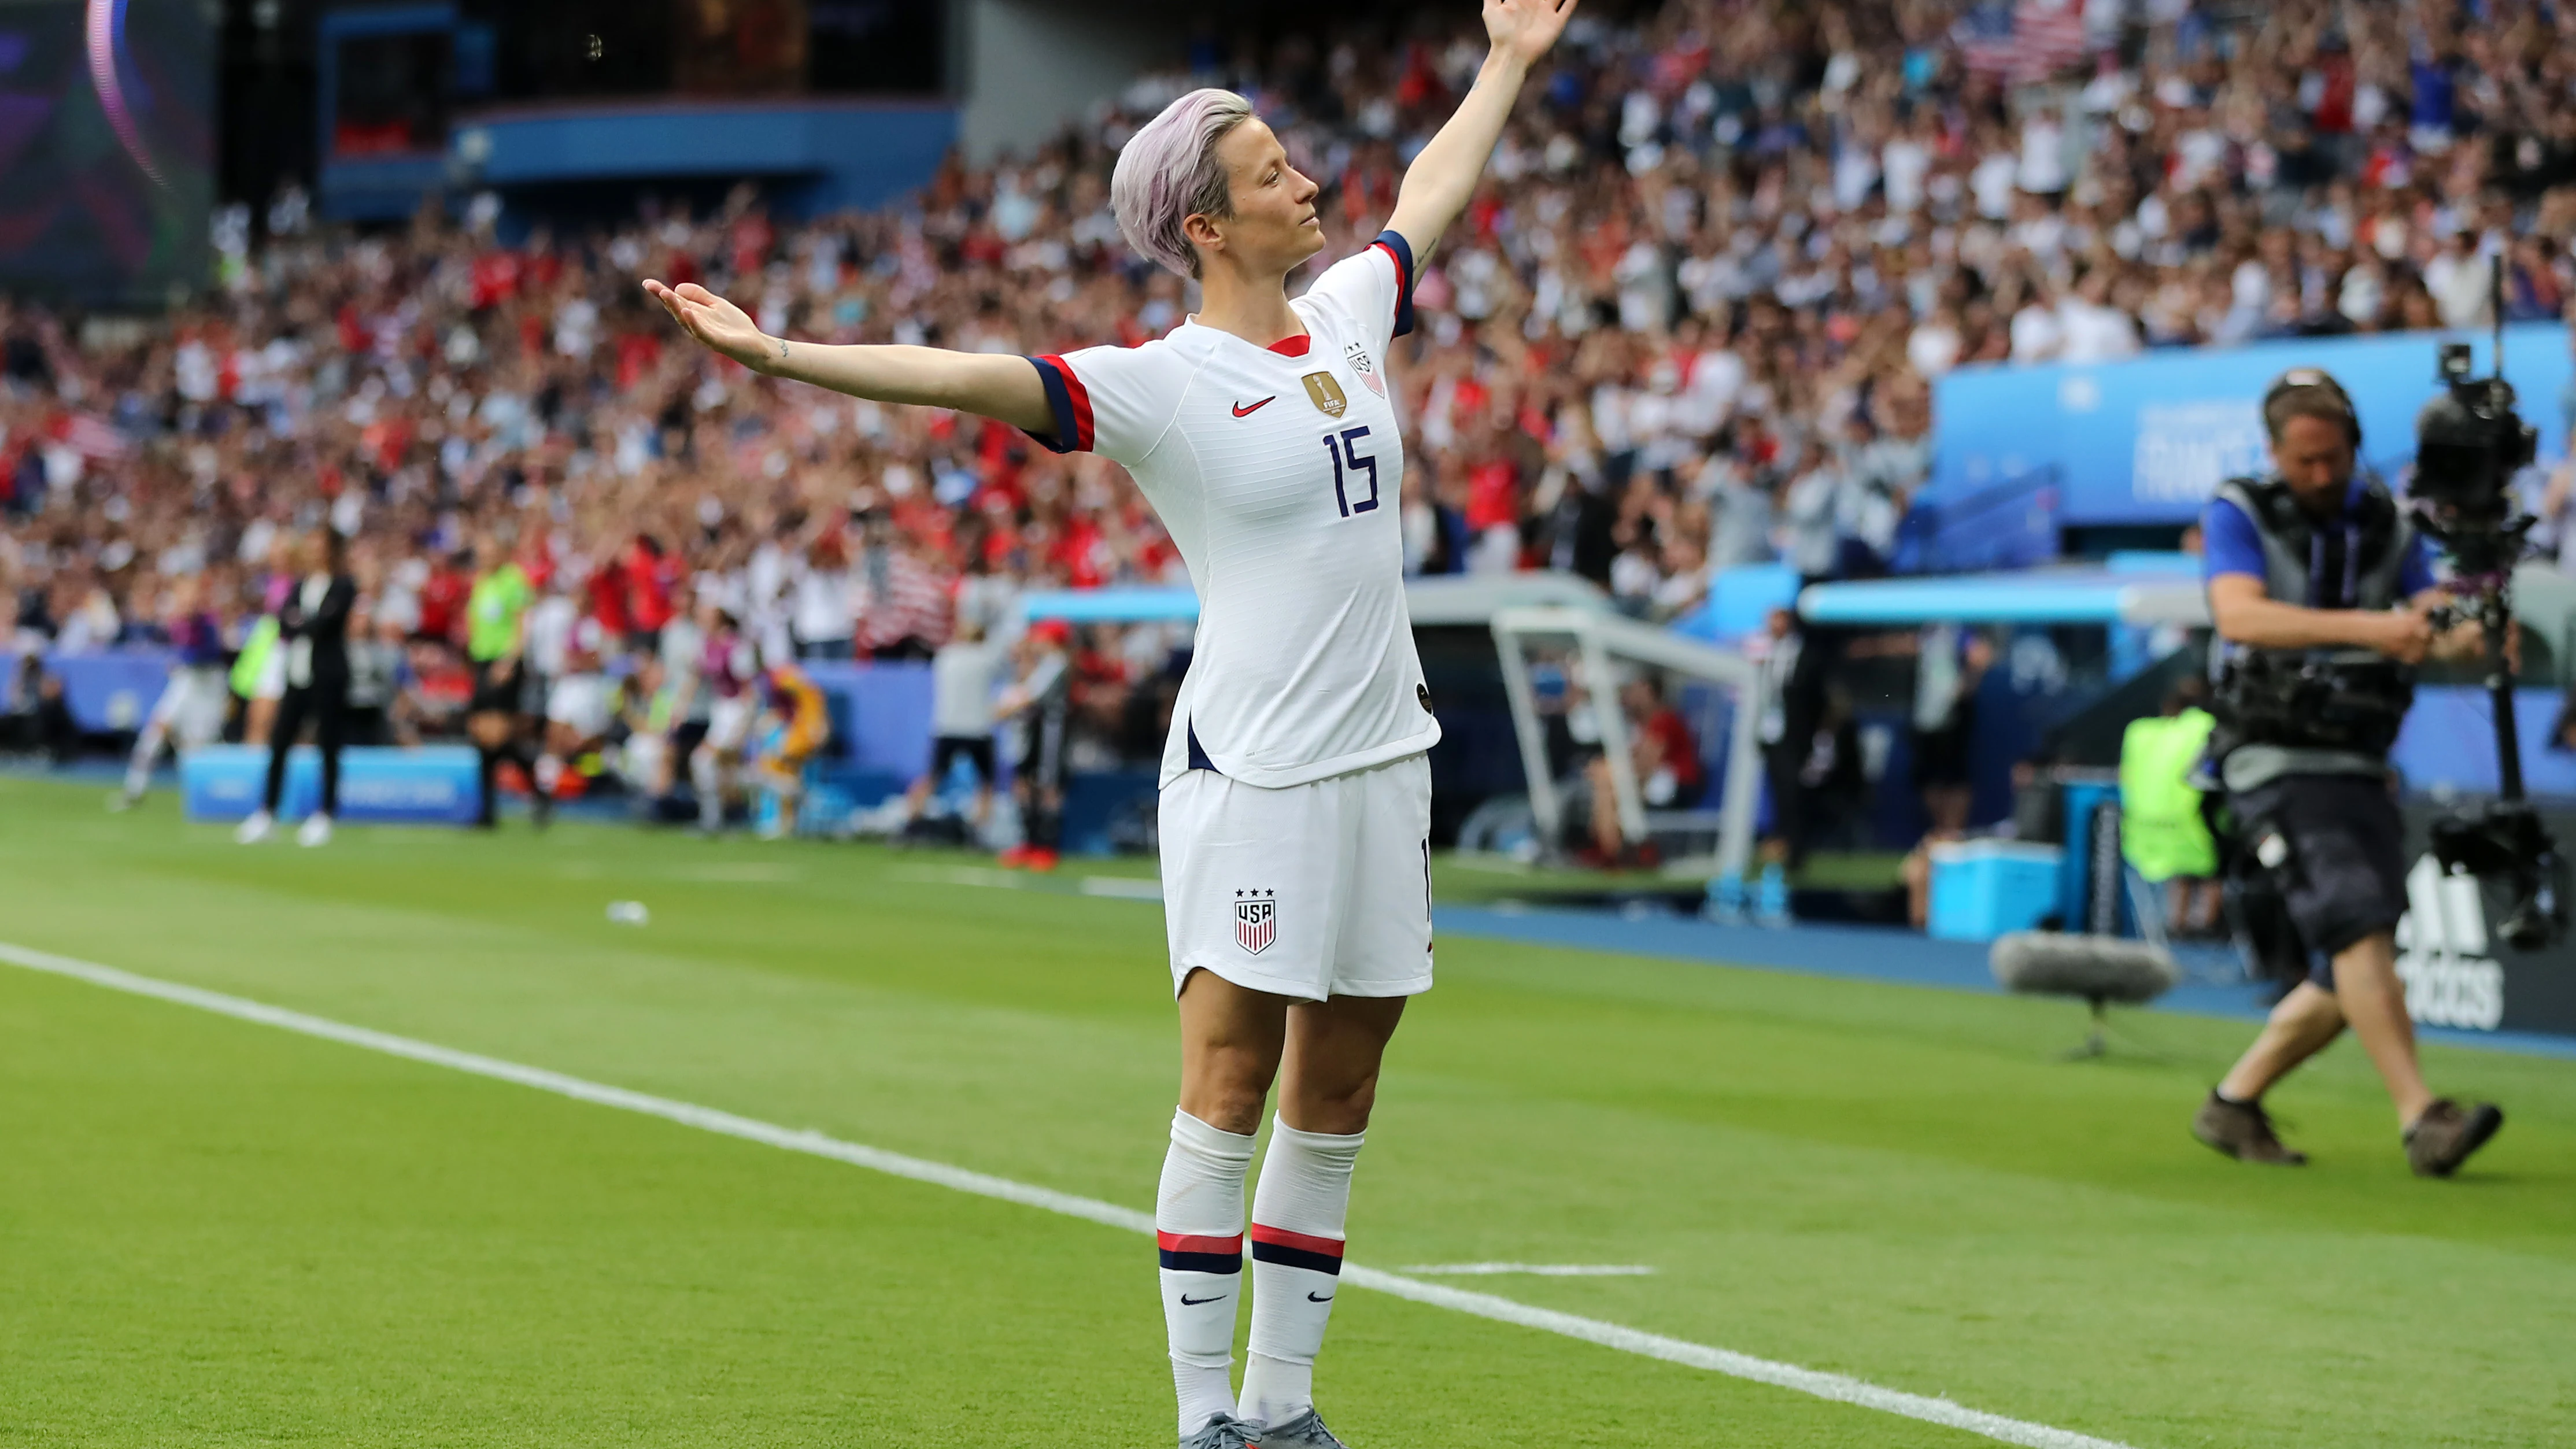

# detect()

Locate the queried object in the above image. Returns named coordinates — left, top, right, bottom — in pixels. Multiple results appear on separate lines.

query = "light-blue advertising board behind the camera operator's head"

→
left=1924, top=321, right=2576, bottom=527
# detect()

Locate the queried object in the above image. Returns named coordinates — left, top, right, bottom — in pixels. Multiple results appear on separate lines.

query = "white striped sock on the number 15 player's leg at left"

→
left=1154, top=1112, right=1252, bottom=1436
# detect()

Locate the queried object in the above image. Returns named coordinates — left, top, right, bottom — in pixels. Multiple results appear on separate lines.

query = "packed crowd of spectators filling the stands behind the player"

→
left=0, top=0, right=2576, bottom=792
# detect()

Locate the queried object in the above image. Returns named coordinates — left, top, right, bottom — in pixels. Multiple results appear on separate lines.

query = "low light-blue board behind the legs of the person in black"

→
left=178, top=744, right=479, bottom=826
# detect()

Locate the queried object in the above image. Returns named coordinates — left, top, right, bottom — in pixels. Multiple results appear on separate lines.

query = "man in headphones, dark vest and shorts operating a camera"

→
left=2192, top=368, right=2504, bottom=1176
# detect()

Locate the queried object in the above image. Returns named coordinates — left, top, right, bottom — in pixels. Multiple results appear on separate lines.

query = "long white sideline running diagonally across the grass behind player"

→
left=0, top=942, right=2130, bottom=1449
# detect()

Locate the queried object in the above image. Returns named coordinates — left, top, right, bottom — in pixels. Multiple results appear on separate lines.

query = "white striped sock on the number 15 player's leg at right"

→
left=1239, top=1119, right=1368, bottom=1423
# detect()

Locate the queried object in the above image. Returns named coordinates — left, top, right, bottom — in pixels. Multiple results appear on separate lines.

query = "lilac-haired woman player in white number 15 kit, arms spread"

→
left=644, top=0, right=1574, bottom=1449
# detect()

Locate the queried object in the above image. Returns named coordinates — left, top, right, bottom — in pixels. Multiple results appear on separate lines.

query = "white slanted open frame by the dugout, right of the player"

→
left=1494, top=605, right=1772, bottom=878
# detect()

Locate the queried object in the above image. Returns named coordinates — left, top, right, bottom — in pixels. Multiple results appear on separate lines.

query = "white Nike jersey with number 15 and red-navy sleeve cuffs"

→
left=1030, top=232, right=1440, bottom=788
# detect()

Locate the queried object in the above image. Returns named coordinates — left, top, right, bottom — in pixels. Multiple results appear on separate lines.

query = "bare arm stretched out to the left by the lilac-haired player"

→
left=644, top=280, right=1056, bottom=433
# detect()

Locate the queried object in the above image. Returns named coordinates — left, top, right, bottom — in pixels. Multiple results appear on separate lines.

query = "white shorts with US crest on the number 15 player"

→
left=1162, top=754, right=1432, bottom=1001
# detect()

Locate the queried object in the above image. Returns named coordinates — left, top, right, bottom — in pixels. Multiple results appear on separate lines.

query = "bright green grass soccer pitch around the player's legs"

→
left=0, top=780, right=2576, bottom=1449
